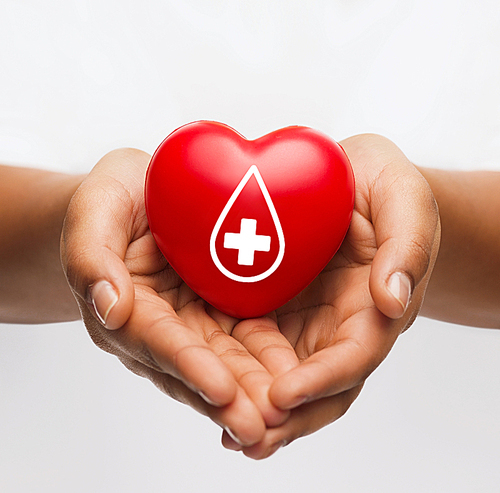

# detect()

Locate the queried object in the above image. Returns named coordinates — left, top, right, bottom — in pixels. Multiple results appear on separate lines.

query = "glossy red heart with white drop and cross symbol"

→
left=145, top=122, right=354, bottom=318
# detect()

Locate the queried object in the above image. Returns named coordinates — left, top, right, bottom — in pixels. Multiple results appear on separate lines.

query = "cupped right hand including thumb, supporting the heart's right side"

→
left=222, top=135, right=440, bottom=458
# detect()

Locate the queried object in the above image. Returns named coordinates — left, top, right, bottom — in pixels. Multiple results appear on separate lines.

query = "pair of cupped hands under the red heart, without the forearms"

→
left=62, top=136, right=439, bottom=459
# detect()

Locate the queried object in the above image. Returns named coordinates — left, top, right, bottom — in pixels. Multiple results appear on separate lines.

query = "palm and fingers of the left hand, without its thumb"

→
left=86, top=221, right=288, bottom=442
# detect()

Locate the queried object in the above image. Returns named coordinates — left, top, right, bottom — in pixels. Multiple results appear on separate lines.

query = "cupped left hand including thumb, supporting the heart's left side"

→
left=61, top=149, right=295, bottom=446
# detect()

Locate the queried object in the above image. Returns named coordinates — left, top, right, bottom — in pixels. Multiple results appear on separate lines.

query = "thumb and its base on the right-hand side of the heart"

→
left=342, top=135, right=439, bottom=318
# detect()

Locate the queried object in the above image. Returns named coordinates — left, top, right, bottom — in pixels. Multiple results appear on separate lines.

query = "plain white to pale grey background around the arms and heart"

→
left=0, top=0, right=500, bottom=493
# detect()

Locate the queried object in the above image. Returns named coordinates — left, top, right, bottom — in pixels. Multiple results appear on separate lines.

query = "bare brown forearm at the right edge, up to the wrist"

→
left=420, top=168, right=500, bottom=328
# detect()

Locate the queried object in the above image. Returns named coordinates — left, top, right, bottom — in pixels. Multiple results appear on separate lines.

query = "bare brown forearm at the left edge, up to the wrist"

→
left=0, top=166, right=82, bottom=323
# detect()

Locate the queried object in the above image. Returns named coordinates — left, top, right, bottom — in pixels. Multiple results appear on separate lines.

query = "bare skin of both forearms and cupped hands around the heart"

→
left=4, top=135, right=492, bottom=459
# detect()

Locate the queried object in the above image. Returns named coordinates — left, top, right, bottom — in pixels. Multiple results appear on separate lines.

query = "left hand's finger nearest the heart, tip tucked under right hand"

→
left=178, top=303, right=289, bottom=427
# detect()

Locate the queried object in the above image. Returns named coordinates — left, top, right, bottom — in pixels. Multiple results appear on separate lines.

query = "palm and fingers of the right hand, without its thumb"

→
left=224, top=200, right=386, bottom=458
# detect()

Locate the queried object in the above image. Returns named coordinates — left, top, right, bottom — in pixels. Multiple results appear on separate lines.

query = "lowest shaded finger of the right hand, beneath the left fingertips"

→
left=222, top=385, right=362, bottom=460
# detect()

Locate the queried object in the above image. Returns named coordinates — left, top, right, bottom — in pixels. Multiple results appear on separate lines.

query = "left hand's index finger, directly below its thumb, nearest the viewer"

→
left=101, top=285, right=237, bottom=406
